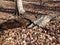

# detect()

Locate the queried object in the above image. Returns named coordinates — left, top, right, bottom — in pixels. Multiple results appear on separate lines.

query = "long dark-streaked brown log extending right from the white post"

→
left=24, top=4, right=60, bottom=14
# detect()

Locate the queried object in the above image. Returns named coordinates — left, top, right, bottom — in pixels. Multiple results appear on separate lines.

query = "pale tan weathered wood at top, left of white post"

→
left=0, top=1, right=15, bottom=9
